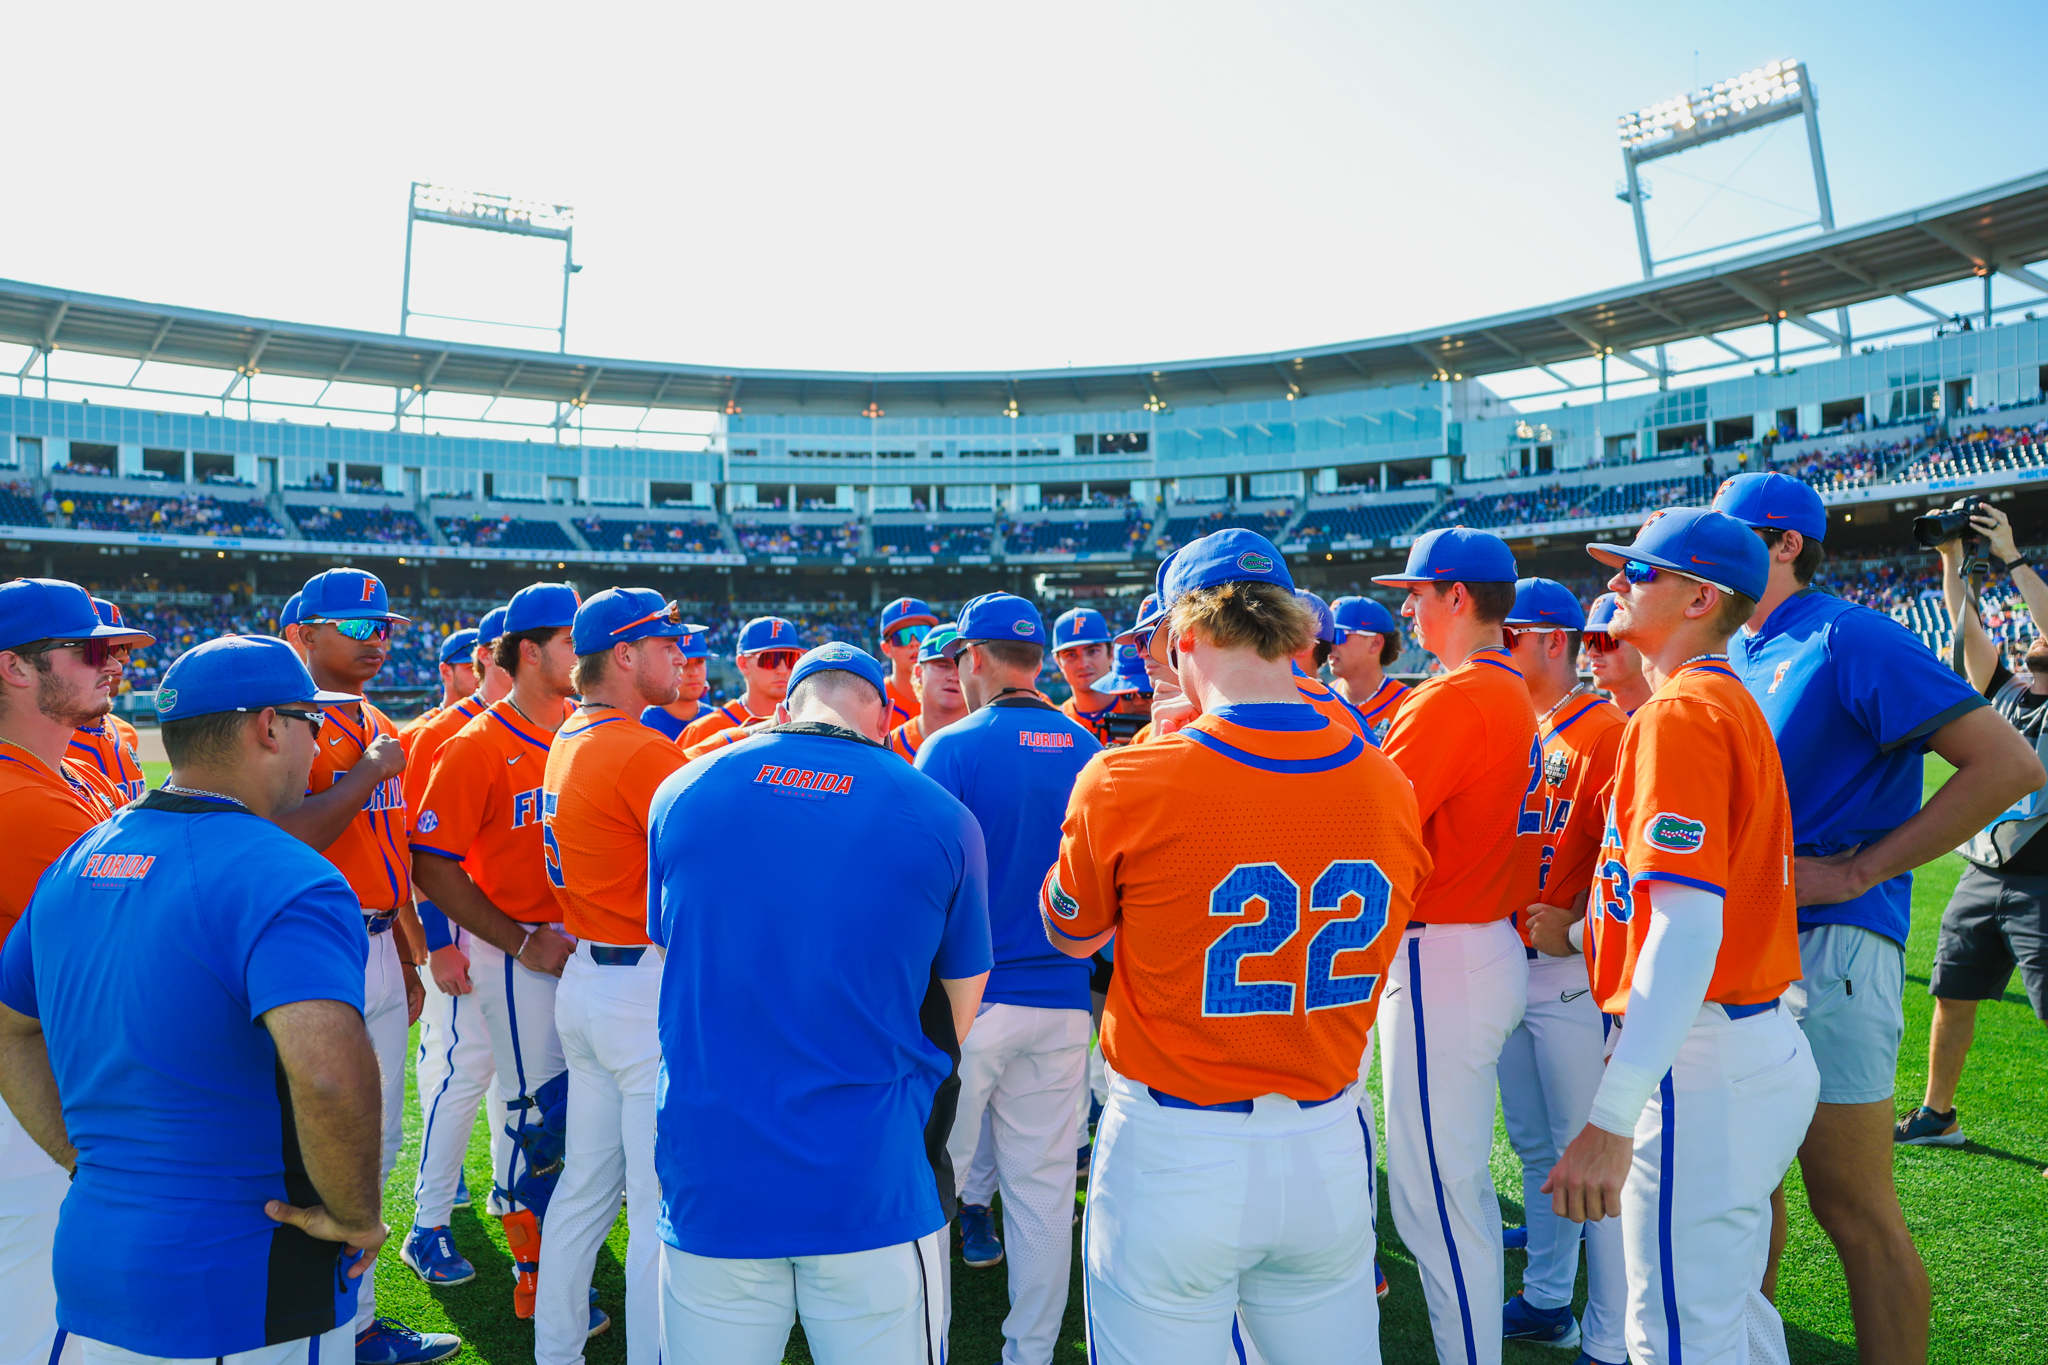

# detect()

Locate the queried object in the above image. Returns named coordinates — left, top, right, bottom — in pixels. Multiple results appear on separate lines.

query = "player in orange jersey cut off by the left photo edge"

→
left=0, top=579, right=152, bottom=1365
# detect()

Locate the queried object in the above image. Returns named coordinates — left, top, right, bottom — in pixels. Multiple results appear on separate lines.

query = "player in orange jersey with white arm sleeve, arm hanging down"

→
left=1546, top=508, right=1821, bottom=1365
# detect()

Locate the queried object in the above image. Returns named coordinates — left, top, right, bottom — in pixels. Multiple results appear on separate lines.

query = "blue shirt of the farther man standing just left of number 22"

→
left=913, top=696, right=1102, bottom=1009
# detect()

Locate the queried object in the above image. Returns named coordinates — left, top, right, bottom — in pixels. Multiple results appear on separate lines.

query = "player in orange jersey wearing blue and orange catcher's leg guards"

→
left=412, top=583, right=578, bottom=1318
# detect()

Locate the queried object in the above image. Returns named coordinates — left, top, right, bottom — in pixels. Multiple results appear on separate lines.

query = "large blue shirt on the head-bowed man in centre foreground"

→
left=647, top=724, right=989, bottom=1259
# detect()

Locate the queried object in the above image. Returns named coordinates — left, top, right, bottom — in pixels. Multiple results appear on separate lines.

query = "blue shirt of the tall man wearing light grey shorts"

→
left=1729, top=587, right=1987, bottom=945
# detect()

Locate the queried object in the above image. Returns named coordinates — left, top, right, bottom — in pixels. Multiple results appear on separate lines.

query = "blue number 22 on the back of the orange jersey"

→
left=1202, top=862, right=1405, bottom=1017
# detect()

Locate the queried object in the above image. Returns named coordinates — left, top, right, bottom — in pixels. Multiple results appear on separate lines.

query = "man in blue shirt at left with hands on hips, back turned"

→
left=0, top=636, right=385, bottom=1365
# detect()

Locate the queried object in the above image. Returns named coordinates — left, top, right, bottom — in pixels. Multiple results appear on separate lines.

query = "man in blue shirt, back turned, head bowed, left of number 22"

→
left=647, top=643, right=989, bottom=1365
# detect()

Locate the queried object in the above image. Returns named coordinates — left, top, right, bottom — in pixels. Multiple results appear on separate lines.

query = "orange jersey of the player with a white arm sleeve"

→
left=1585, top=659, right=1800, bottom=1015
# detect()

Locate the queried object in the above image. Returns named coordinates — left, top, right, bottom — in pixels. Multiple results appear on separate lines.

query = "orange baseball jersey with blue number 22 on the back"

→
left=1038, top=704, right=1430, bottom=1105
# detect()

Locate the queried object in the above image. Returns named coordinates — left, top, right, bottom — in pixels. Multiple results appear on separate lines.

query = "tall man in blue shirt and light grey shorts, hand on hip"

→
left=1714, top=473, right=2042, bottom=1363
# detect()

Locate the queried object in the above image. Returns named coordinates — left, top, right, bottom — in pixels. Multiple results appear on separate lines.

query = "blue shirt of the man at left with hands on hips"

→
left=0, top=790, right=369, bottom=1359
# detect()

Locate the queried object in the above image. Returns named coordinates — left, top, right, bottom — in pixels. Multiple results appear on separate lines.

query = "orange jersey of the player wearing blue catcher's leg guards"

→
left=412, top=698, right=557, bottom=925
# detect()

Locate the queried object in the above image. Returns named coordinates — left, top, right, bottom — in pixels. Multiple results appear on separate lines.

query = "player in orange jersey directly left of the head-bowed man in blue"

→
left=532, top=587, right=688, bottom=1365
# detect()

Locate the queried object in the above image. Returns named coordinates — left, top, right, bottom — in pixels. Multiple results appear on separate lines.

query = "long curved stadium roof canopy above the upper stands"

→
left=0, top=172, right=2048, bottom=417
